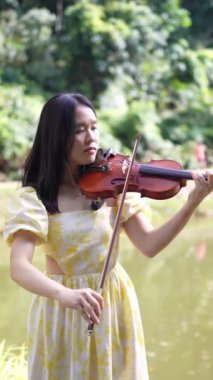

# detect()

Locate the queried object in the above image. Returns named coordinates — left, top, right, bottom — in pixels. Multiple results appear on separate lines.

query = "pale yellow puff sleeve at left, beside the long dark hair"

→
left=3, top=186, right=48, bottom=245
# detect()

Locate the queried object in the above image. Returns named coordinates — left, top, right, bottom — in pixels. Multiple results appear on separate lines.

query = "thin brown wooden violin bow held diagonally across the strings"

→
left=88, top=135, right=142, bottom=336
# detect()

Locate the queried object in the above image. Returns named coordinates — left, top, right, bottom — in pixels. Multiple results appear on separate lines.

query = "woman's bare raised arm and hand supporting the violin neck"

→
left=123, top=171, right=213, bottom=257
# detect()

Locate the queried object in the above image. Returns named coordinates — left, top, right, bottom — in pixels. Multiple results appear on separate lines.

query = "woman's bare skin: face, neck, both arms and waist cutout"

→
left=10, top=106, right=213, bottom=323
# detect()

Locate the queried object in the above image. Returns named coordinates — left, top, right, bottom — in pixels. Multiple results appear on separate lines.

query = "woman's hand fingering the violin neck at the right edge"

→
left=189, top=170, right=213, bottom=204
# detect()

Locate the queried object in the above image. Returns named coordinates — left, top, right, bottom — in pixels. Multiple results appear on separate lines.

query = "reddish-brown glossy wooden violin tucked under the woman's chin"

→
left=79, top=153, right=207, bottom=200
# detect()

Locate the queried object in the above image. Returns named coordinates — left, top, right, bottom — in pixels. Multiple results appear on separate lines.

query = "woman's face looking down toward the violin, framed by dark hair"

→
left=69, top=105, right=99, bottom=172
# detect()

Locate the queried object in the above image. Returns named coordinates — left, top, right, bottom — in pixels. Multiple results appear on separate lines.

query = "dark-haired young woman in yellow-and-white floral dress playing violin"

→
left=4, top=93, right=213, bottom=380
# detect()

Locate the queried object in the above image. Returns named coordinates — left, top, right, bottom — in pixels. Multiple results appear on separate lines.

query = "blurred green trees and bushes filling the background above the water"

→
left=0, top=0, right=213, bottom=170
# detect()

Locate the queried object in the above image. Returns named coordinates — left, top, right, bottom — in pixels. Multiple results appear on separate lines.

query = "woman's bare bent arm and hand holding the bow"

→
left=10, top=230, right=103, bottom=323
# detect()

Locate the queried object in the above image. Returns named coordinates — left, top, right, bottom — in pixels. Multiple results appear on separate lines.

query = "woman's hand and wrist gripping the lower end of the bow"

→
left=58, top=287, right=103, bottom=323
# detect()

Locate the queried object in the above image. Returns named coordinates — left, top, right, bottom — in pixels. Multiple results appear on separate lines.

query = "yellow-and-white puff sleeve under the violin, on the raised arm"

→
left=117, top=192, right=152, bottom=223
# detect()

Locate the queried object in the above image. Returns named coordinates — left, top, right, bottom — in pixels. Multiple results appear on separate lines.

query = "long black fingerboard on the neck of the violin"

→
left=139, top=164, right=193, bottom=180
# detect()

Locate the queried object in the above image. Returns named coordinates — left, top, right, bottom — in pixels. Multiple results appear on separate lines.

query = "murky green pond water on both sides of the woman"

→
left=0, top=183, right=213, bottom=380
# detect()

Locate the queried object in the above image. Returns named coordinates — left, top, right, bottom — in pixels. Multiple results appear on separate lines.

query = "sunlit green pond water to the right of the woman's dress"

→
left=122, top=220, right=213, bottom=380
